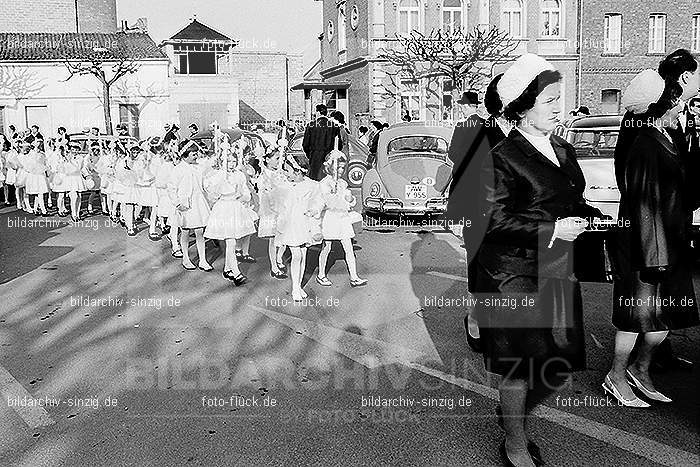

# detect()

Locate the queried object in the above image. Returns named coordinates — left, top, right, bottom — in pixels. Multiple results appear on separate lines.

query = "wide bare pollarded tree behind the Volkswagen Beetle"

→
left=378, top=26, right=518, bottom=118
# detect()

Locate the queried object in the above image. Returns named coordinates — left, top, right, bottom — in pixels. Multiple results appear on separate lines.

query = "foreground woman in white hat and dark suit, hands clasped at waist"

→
left=475, top=54, right=602, bottom=466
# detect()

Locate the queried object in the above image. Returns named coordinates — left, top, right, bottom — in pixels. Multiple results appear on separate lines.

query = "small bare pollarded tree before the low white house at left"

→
left=64, top=57, right=140, bottom=135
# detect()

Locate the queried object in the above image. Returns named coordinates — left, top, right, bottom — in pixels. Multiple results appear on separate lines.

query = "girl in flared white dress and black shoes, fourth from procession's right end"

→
left=204, top=143, right=258, bottom=286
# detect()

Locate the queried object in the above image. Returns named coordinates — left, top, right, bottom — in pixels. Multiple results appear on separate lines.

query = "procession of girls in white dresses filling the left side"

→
left=0, top=118, right=367, bottom=301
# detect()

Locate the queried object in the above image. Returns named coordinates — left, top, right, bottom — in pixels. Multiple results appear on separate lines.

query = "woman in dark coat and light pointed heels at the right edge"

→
left=603, top=70, right=698, bottom=407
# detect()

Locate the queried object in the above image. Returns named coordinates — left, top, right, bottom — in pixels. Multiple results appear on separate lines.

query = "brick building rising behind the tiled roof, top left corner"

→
left=0, top=0, right=117, bottom=33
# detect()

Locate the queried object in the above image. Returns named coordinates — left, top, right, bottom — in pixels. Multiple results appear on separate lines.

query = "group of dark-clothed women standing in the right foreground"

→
left=448, top=49, right=700, bottom=467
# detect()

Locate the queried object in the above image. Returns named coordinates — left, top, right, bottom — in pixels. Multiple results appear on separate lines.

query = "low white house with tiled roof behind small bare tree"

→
left=0, top=30, right=171, bottom=138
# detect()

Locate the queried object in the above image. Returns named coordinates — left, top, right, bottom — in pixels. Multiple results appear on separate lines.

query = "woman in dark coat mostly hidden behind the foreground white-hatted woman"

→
left=445, top=74, right=512, bottom=352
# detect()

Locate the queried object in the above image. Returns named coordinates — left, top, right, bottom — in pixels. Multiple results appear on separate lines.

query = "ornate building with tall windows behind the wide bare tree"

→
left=306, top=0, right=579, bottom=129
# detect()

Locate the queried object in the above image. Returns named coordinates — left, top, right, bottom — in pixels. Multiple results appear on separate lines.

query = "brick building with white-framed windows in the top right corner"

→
left=580, top=0, right=700, bottom=113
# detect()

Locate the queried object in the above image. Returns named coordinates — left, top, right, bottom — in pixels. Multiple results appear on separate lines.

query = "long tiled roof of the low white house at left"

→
left=0, top=32, right=167, bottom=61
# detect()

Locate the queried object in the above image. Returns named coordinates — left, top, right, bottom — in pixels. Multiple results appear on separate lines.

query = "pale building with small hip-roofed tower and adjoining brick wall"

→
left=161, top=18, right=303, bottom=128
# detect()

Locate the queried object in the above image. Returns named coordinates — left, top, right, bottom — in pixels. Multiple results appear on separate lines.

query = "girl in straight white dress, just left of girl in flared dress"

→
left=173, top=140, right=214, bottom=271
